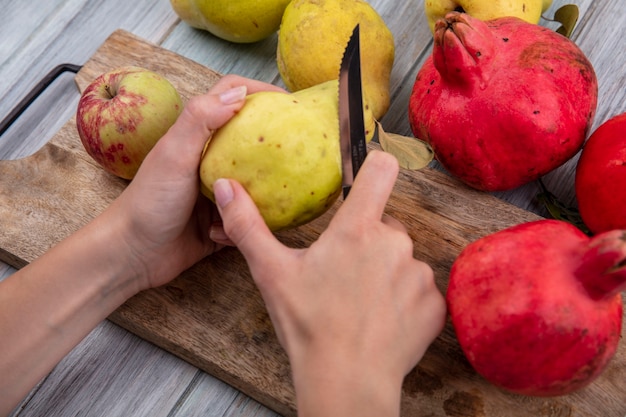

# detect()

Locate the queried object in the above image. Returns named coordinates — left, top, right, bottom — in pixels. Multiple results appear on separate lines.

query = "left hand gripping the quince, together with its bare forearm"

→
left=0, top=76, right=282, bottom=416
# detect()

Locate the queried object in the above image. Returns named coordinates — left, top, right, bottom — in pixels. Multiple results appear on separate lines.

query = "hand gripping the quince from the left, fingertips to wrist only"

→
left=106, top=75, right=284, bottom=288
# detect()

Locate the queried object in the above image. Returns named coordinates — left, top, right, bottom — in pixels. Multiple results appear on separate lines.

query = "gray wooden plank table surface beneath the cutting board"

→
left=0, top=0, right=626, bottom=417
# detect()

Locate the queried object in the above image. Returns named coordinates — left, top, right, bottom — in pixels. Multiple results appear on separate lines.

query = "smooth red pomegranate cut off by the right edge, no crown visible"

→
left=575, top=113, right=626, bottom=233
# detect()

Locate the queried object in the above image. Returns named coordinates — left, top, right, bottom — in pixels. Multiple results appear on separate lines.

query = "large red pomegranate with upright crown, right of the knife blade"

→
left=409, top=12, right=598, bottom=191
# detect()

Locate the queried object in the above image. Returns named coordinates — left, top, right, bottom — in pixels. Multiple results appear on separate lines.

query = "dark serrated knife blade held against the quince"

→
left=339, top=25, right=367, bottom=199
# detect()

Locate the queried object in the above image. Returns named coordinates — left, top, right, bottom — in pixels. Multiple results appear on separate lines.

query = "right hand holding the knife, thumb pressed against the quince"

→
left=214, top=151, right=446, bottom=417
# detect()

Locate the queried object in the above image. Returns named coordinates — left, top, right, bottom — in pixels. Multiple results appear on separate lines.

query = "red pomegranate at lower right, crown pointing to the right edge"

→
left=446, top=220, right=626, bottom=396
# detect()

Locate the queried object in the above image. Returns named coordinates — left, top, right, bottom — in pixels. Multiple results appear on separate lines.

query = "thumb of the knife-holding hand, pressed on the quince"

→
left=213, top=179, right=286, bottom=264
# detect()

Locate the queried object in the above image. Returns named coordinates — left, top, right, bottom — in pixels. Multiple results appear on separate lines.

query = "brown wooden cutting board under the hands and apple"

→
left=0, top=31, right=626, bottom=417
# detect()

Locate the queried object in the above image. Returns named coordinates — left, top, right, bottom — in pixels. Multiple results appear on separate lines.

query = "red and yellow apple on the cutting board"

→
left=76, top=66, right=183, bottom=179
